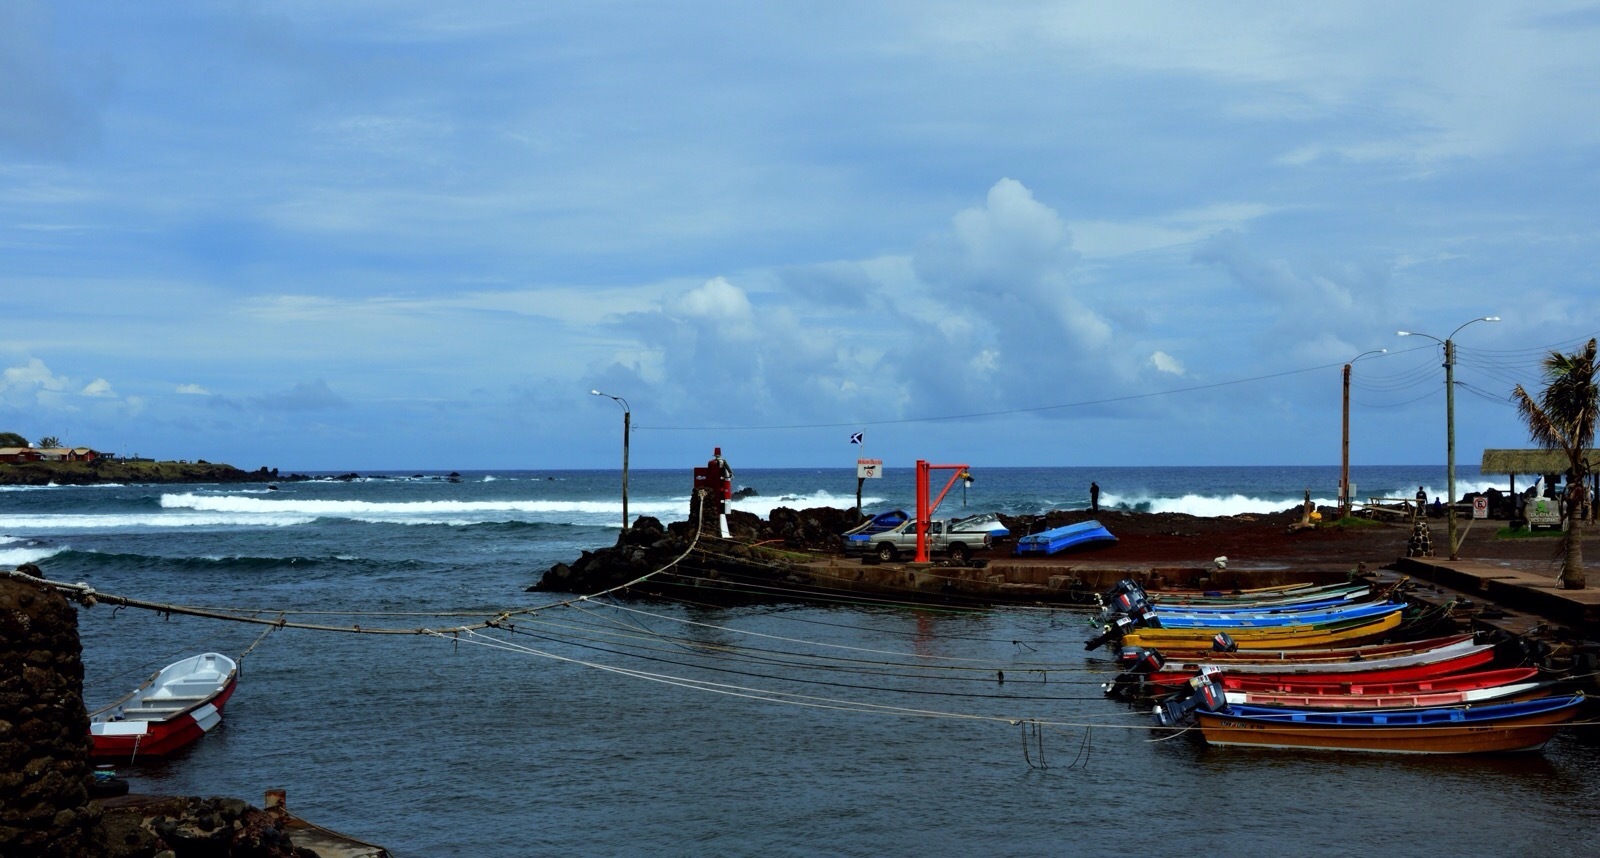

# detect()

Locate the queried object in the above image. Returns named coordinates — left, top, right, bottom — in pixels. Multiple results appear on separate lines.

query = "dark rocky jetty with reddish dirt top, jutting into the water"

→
left=540, top=506, right=1587, bottom=603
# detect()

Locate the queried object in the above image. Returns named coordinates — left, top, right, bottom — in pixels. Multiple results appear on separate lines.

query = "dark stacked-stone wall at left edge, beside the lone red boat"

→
left=0, top=578, right=102, bottom=858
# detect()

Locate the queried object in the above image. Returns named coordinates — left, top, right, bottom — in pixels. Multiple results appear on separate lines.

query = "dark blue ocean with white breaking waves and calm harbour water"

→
left=0, top=463, right=1600, bottom=856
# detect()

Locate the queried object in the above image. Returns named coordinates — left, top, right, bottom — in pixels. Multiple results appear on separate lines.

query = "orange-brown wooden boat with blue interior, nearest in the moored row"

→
left=1195, top=695, right=1584, bottom=754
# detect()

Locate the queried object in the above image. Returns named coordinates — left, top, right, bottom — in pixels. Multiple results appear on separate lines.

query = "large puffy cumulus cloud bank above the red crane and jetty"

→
left=594, top=179, right=1147, bottom=429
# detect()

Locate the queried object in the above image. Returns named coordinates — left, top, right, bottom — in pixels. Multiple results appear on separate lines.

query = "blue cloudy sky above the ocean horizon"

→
left=0, top=0, right=1600, bottom=471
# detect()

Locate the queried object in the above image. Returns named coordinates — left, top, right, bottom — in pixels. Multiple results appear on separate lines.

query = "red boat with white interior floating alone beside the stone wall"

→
left=90, top=653, right=238, bottom=759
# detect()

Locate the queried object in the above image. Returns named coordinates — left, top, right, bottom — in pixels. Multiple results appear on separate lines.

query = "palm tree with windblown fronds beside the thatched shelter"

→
left=1512, top=339, right=1600, bottom=589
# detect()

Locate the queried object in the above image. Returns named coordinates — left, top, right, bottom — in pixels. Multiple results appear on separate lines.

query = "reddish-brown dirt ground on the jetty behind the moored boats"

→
left=997, top=509, right=1600, bottom=576
